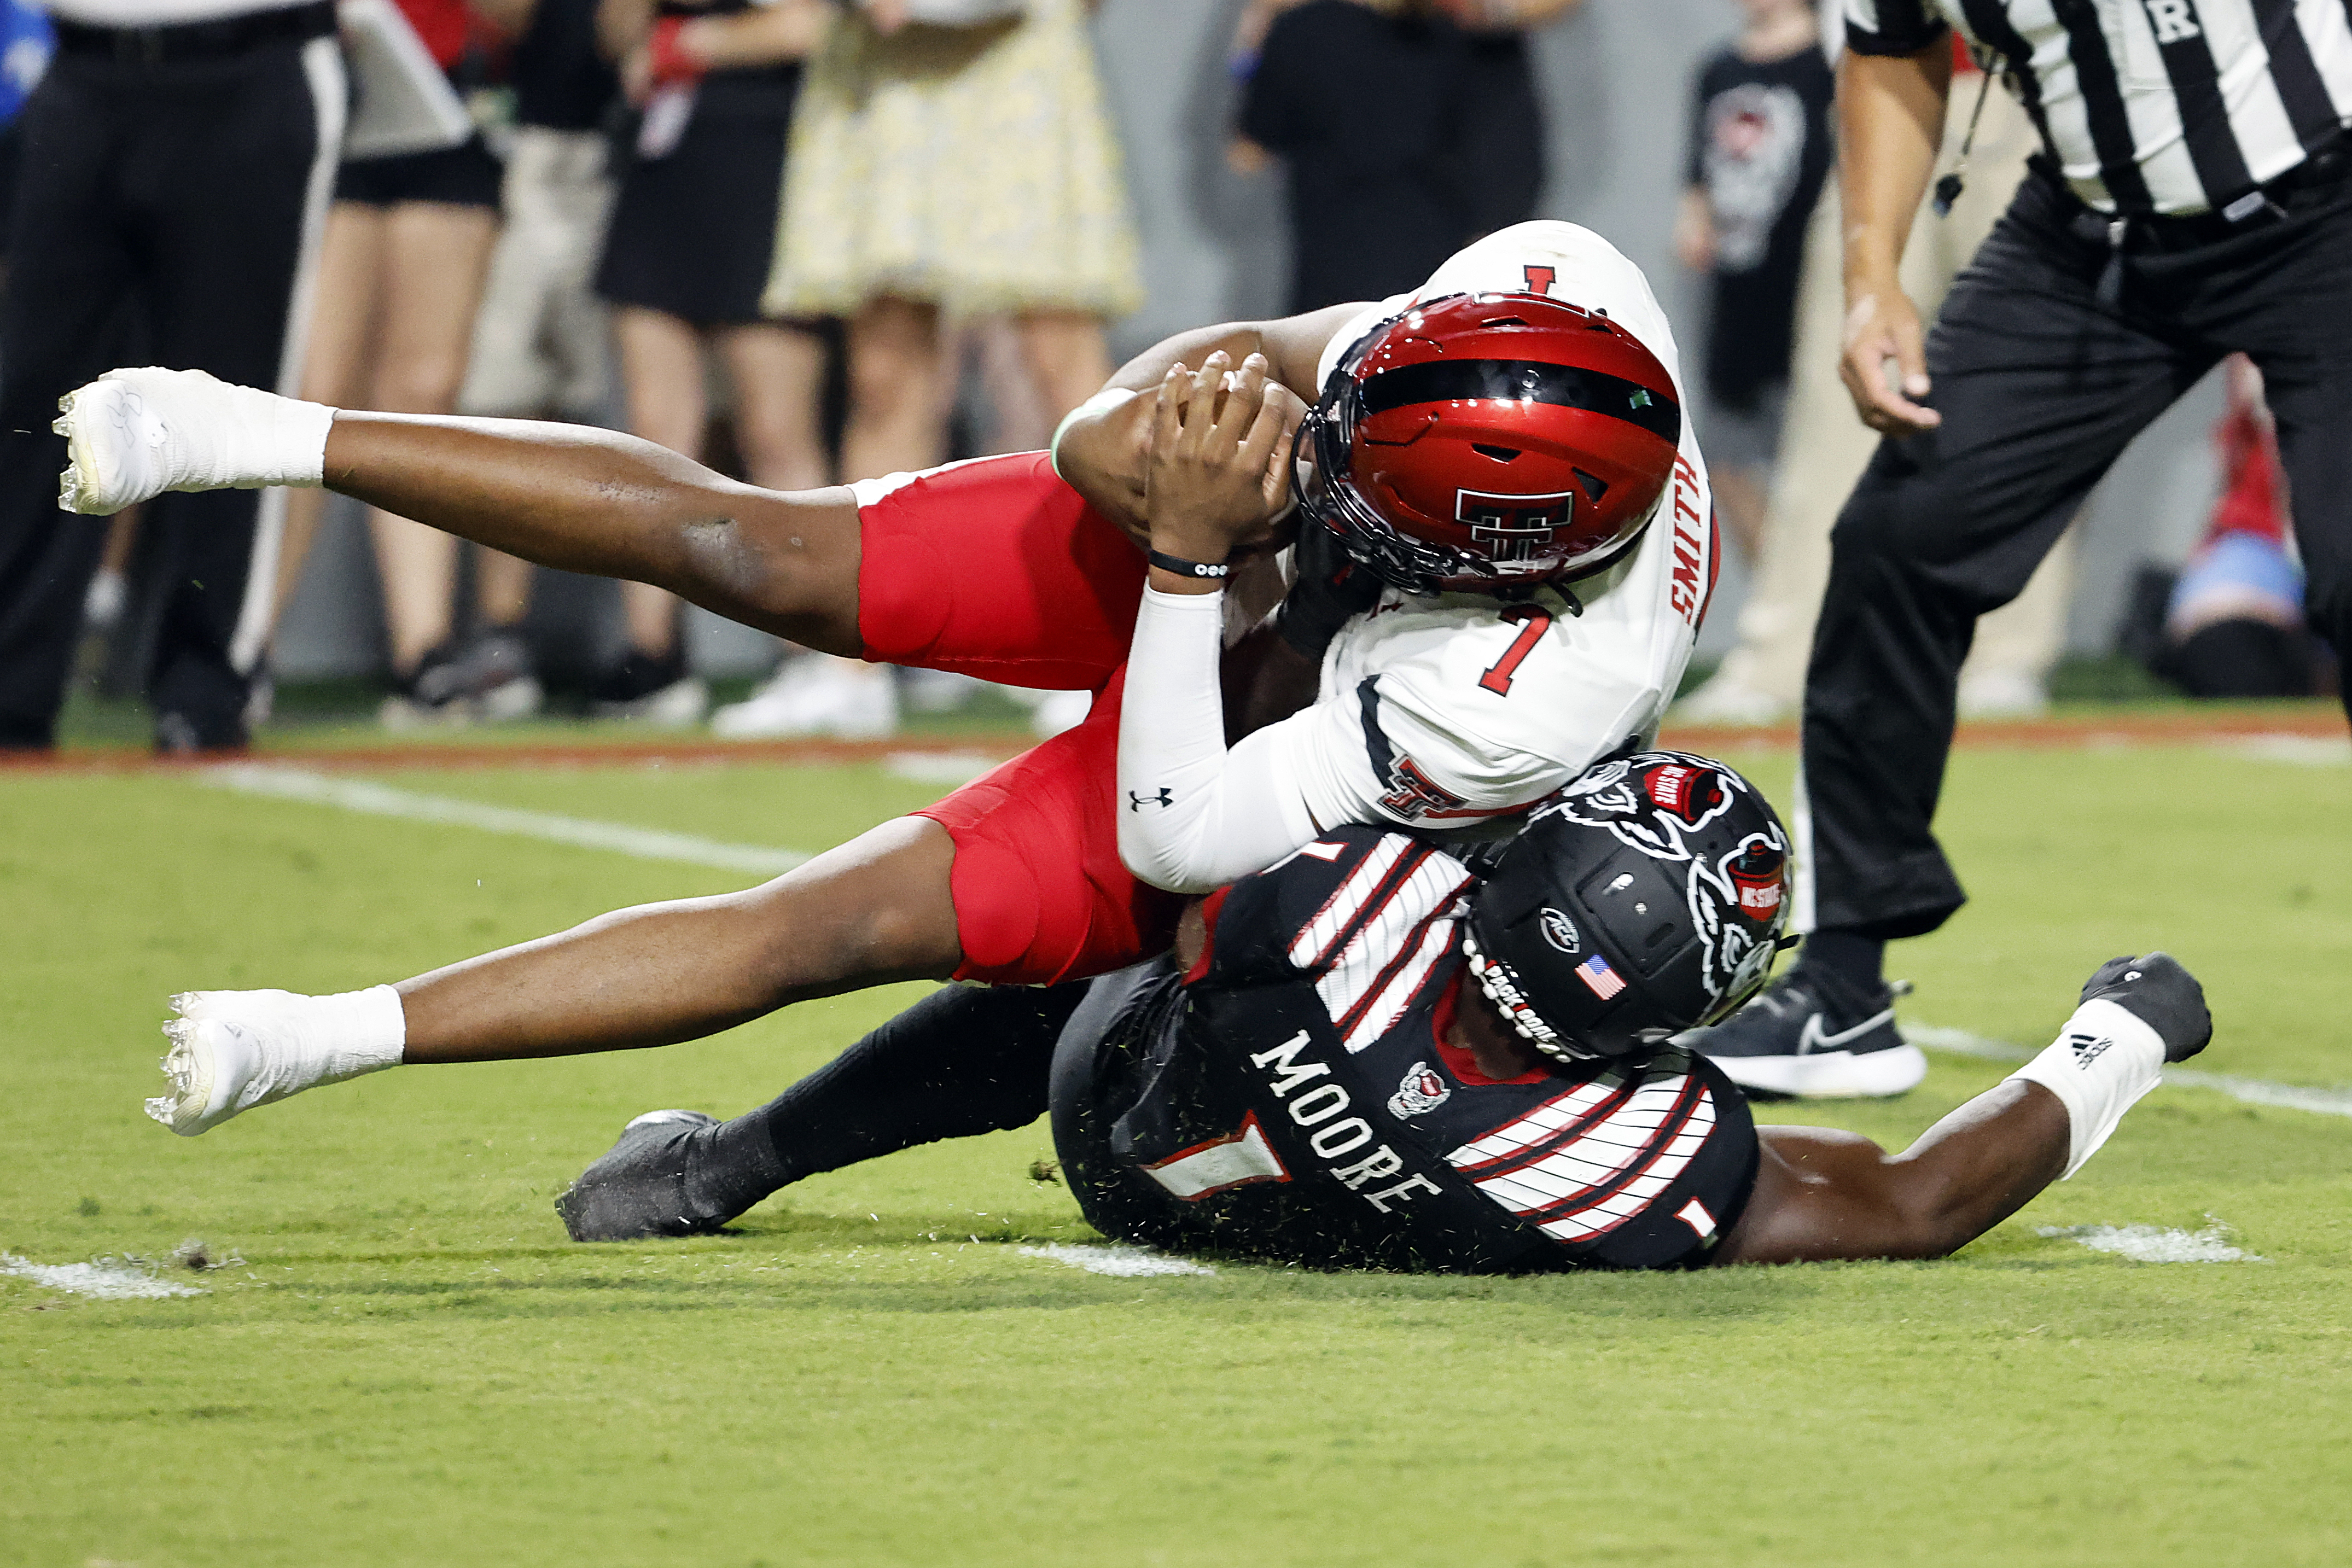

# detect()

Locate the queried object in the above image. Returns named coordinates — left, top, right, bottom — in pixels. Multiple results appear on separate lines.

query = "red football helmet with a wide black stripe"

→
left=1291, top=294, right=1682, bottom=592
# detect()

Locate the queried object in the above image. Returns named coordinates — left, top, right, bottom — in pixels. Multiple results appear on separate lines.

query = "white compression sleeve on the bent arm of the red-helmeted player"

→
left=1117, top=588, right=1315, bottom=893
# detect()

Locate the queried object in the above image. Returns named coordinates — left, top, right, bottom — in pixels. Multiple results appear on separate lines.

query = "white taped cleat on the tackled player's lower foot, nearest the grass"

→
left=146, top=985, right=400, bottom=1138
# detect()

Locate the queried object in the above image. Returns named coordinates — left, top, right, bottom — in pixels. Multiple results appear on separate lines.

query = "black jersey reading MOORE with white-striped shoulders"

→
left=1056, top=827, right=1757, bottom=1272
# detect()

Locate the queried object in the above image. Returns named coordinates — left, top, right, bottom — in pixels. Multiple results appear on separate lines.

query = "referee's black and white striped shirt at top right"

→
left=1844, top=0, right=2352, bottom=219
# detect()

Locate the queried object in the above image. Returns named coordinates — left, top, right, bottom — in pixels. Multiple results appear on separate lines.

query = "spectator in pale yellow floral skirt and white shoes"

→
left=743, top=0, right=1141, bottom=736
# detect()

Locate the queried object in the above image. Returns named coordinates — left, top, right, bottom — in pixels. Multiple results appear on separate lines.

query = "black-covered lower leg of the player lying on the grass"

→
left=715, top=983, right=1087, bottom=1197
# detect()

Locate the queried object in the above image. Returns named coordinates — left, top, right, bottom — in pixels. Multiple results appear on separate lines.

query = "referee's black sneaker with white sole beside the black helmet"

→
left=1675, top=964, right=1926, bottom=1100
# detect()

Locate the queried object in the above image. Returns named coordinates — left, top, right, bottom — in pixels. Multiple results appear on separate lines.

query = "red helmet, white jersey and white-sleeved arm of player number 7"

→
left=1091, top=223, right=1717, bottom=891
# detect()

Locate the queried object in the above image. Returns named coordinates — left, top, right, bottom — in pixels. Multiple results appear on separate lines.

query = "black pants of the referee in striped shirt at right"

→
left=1802, top=167, right=2352, bottom=940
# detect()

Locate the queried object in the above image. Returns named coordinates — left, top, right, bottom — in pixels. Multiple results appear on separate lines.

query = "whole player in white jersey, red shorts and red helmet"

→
left=45, top=223, right=1715, bottom=1135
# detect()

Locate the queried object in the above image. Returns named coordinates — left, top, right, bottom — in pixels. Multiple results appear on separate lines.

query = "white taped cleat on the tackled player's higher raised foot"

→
left=49, top=364, right=334, bottom=517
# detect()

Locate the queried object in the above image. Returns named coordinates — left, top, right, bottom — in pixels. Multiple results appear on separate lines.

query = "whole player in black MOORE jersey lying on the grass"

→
left=557, top=752, right=2211, bottom=1272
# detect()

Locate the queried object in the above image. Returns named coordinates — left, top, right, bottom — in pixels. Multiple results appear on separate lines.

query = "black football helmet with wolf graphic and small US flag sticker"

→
left=1465, top=752, right=1788, bottom=1060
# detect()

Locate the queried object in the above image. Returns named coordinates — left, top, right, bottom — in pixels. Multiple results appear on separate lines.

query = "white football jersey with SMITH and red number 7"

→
left=1284, top=221, right=1719, bottom=830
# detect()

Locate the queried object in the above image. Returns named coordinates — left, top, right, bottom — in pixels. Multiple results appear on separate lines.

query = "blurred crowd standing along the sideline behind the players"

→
left=0, top=0, right=2336, bottom=748
